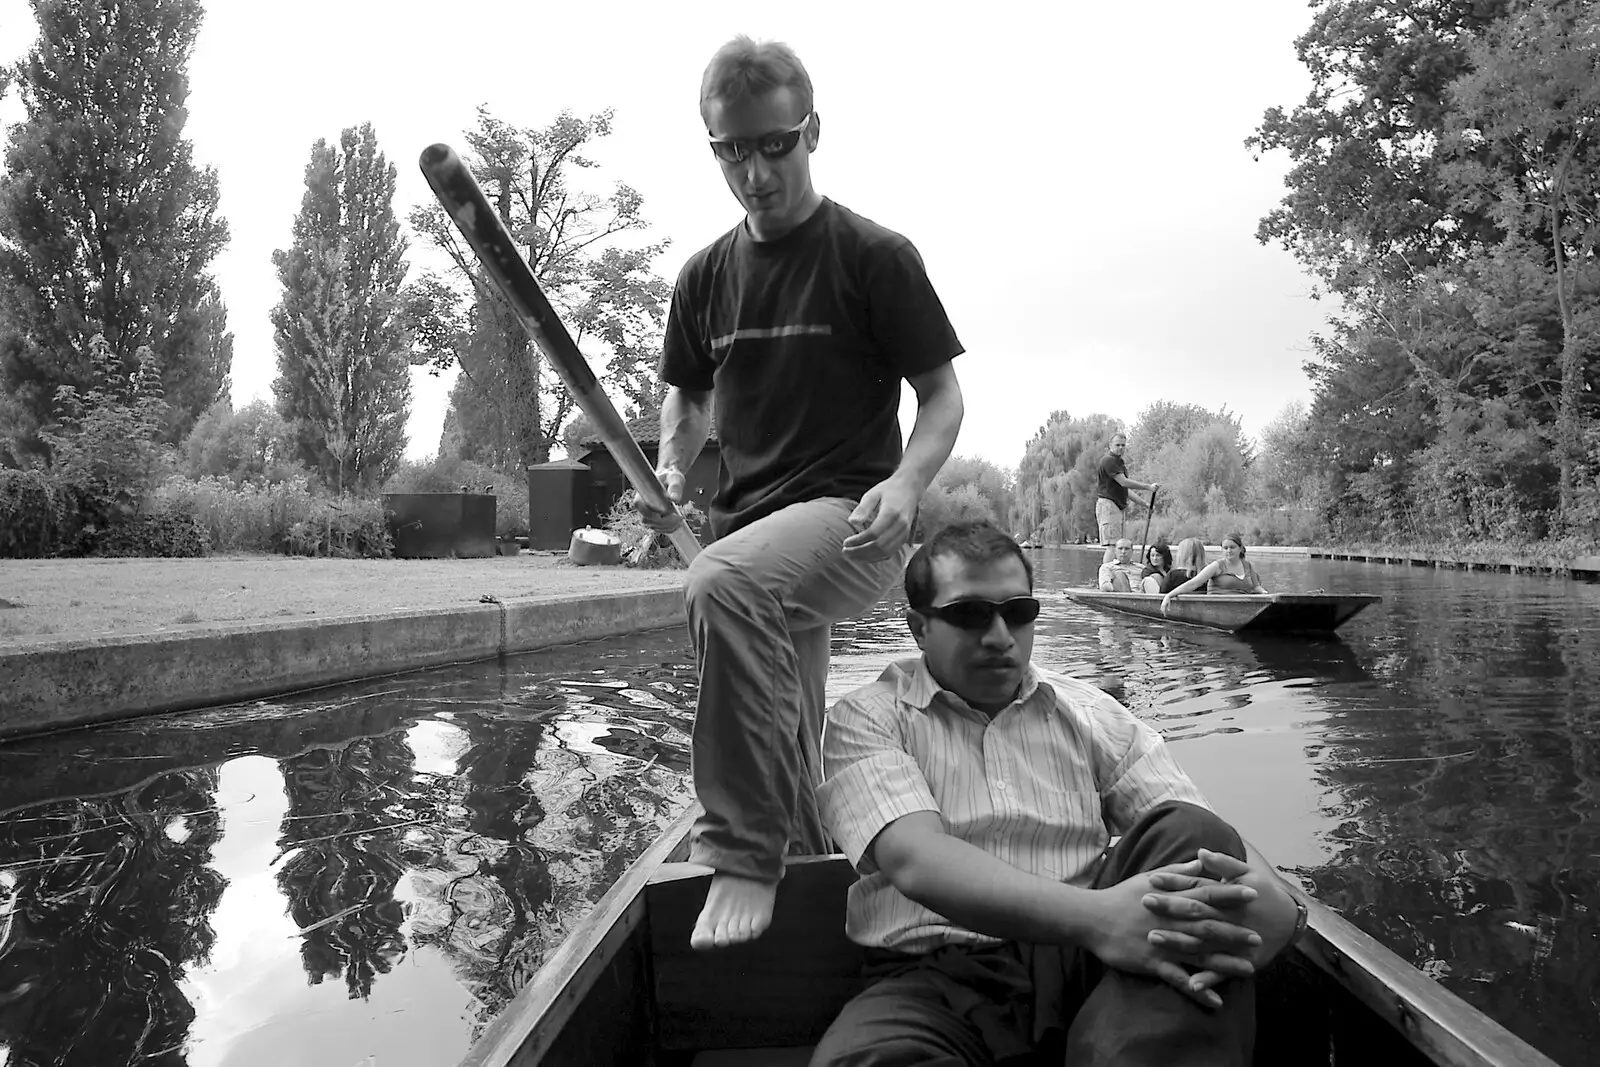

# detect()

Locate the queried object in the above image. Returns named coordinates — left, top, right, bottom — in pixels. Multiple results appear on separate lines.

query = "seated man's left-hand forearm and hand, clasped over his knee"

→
left=867, top=811, right=1261, bottom=1006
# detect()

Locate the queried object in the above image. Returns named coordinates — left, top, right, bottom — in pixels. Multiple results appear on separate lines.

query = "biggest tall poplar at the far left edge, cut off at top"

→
left=0, top=0, right=232, bottom=462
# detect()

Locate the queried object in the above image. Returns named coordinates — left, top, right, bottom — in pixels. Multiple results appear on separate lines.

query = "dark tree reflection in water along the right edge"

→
left=1302, top=597, right=1600, bottom=1064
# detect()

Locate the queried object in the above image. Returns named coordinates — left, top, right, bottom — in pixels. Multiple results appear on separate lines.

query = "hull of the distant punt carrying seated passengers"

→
left=1067, top=589, right=1384, bottom=633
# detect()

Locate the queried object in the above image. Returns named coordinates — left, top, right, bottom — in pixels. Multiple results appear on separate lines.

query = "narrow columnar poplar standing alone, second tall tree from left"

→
left=272, top=123, right=411, bottom=491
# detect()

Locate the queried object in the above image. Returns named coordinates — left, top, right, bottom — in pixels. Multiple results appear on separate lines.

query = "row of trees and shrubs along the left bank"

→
left=0, top=0, right=667, bottom=555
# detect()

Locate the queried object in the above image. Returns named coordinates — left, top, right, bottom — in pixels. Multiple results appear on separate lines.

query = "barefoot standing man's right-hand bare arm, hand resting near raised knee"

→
left=845, top=363, right=965, bottom=560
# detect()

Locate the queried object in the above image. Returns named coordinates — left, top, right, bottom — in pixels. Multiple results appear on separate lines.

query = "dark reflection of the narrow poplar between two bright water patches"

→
left=277, top=733, right=426, bottom=1000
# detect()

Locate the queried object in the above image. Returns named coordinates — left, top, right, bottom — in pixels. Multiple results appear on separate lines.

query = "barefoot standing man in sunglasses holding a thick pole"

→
left=640, top=37, right=962, bottom=949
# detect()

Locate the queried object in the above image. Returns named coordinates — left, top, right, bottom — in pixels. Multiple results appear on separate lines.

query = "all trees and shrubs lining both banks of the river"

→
left=0, top=0, right=1600, bottom=553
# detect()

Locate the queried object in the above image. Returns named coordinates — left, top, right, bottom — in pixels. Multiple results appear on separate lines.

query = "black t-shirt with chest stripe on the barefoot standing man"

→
left=661, top=198, right=962, bottom=537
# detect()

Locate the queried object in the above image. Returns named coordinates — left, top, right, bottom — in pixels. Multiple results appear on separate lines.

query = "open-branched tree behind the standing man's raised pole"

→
left=408, top=109, right=670, bottom=467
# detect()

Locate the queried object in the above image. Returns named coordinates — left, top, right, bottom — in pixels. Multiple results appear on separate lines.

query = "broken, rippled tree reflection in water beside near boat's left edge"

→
left=406, top=678, right=688, bottom=1027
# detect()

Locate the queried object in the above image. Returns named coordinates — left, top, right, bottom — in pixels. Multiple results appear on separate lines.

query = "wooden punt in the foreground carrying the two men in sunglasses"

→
left=462, top=805, right=1555, bottom=1067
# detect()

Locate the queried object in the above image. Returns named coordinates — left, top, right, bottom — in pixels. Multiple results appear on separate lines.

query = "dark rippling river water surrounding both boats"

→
left=0, top=549, right=1600, bottom=1067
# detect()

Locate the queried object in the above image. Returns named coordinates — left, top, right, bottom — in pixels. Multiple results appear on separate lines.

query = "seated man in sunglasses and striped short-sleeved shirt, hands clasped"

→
left=811, top=523, right=1304, bottom=1067
